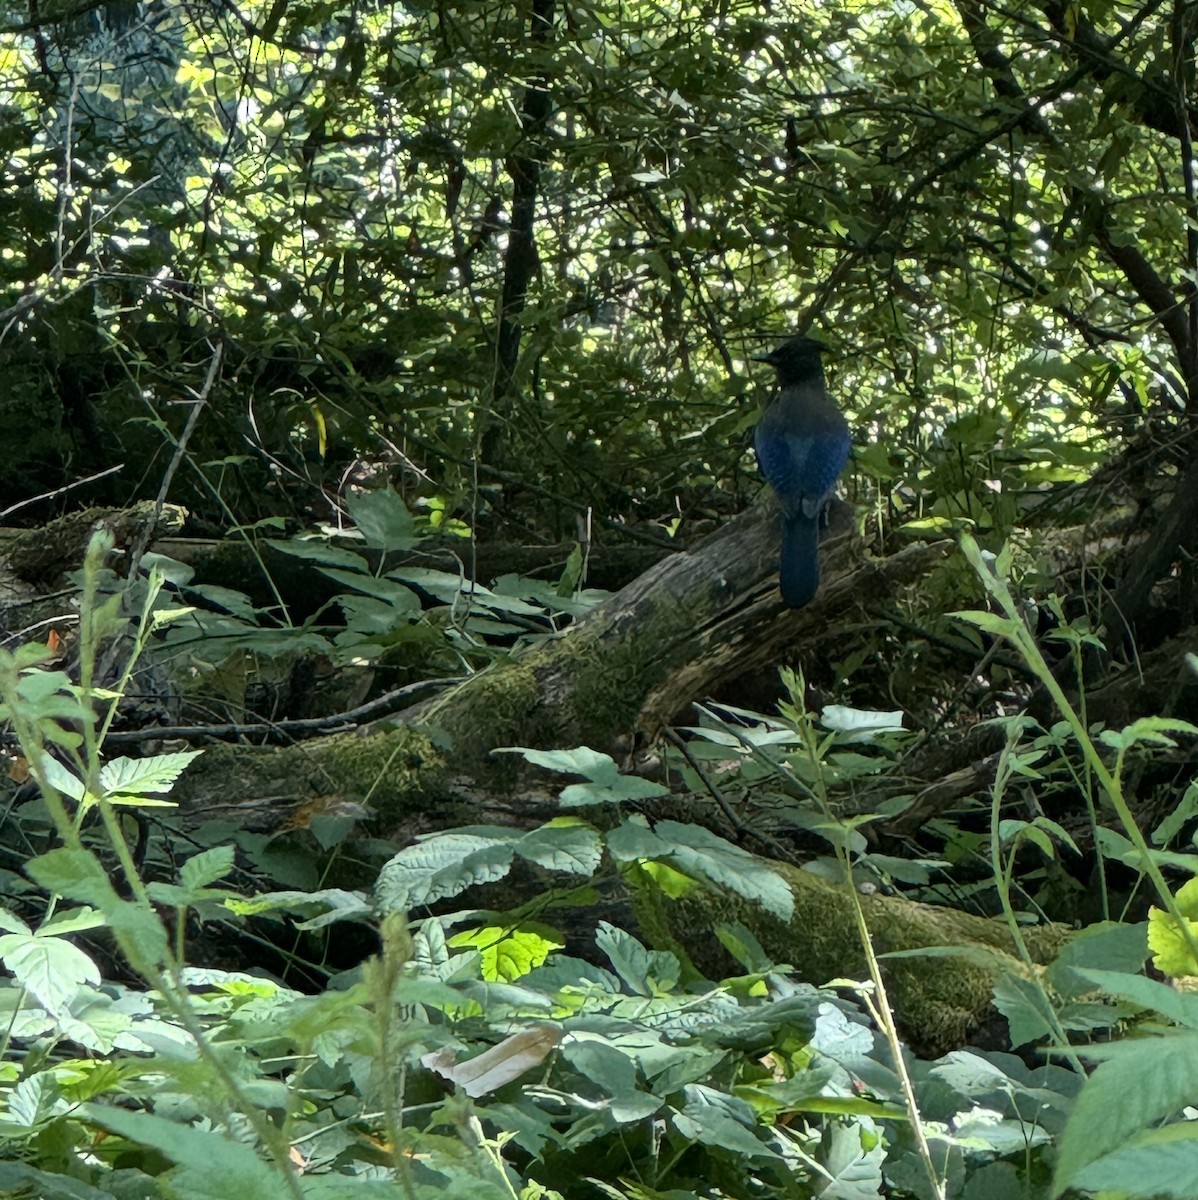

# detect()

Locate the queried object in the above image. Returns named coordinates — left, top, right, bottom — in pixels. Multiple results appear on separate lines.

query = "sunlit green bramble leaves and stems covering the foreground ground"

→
left=0, top=542, right=1198, bottom=1200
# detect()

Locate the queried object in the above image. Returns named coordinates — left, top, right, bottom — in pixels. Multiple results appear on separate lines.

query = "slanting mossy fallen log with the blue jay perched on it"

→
left=175, top=496, right=951, bottom=836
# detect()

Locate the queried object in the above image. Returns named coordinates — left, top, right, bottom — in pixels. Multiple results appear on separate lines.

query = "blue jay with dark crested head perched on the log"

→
left=753, top=337, right=851, bottom=608
